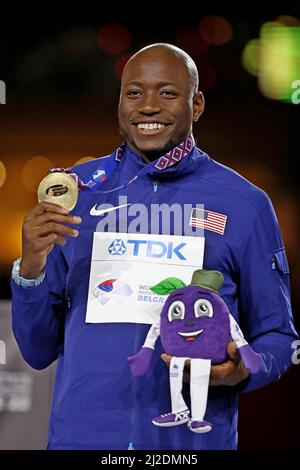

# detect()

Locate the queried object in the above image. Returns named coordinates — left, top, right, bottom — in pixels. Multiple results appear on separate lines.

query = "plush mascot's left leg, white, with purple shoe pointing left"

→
left=152, top=356, right=190, bottom=426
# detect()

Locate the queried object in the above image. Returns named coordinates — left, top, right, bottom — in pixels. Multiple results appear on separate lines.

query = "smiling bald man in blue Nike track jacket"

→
left=11, top=44, right=296, bottom=449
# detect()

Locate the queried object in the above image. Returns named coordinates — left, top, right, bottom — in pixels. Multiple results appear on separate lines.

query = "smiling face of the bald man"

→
left=119, top=50, right=203, bottom=160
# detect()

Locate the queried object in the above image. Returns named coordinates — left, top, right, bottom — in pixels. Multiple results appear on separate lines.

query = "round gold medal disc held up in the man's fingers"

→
left=38, top=172, right=78, bottom=211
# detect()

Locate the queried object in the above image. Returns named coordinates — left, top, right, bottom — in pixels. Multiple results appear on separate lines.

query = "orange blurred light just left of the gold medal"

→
left=22, top=156, right=55, bottom=192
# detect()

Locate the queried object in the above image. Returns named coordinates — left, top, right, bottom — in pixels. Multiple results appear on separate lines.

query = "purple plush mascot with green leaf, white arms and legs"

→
left=128, top=269, right=261, bottom=433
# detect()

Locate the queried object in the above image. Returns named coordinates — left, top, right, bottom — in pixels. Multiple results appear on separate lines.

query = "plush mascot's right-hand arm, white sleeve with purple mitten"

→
left=229, top=315, right=262, bottom=374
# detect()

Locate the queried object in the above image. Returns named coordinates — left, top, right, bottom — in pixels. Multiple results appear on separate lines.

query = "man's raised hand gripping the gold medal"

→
left=20, top=202, right=81, bottom=279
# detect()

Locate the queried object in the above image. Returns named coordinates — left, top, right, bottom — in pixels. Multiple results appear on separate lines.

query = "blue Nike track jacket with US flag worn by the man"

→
left=11, top=142, right=297, bottom=450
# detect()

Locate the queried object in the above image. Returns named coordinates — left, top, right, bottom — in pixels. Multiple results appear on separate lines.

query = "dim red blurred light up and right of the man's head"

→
left=199, top=15, right=233, bottom=46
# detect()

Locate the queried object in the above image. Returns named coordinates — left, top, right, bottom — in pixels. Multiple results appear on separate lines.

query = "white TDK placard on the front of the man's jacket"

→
left=86, top=232, right=204, bottom=324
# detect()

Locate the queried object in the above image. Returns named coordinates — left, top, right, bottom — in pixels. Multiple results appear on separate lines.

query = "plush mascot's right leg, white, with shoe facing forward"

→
left=188, top=359, right=212, bottom=433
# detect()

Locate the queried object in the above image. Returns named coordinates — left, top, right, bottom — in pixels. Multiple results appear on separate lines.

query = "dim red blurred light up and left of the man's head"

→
left=97, top=23, right=132, bottom=55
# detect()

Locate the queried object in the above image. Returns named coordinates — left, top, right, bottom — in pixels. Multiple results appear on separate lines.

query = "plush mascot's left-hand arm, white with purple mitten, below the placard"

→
left=128, top=321, right=160, bottom=377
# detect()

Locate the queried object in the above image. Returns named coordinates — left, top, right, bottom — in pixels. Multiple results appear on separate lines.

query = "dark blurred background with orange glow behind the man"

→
left=0, top=6, right=300, bottom=449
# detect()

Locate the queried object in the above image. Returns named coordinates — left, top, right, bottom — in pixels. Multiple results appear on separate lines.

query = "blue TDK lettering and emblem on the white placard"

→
left=108, top=239, right=186, bottom=260
